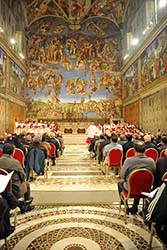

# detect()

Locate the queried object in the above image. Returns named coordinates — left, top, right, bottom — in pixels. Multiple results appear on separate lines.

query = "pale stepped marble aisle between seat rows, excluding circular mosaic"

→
left=31, top=145, right=119, bottom=205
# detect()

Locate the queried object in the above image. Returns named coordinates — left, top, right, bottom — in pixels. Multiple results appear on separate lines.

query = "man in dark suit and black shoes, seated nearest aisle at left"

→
left=0, top=143, right=33, bottom=213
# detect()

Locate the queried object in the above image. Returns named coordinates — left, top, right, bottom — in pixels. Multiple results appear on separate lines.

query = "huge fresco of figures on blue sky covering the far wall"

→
left=27, top=18, right=122, bottom=120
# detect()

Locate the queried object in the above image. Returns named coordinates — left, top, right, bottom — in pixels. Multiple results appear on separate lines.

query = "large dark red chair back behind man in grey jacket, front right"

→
left=128, top=168, right=154, bottom=198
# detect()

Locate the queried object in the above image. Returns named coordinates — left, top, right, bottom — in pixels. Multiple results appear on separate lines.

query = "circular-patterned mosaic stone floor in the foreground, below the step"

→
left=0, top=205, right=162, bottom=250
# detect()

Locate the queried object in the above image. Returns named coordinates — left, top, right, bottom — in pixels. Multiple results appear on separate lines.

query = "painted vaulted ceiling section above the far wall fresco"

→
left=25, top=0, right=127, bottom=35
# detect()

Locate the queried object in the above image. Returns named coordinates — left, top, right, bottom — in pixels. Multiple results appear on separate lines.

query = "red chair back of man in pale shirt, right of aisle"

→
left=108, top=148, right=123, bottom=168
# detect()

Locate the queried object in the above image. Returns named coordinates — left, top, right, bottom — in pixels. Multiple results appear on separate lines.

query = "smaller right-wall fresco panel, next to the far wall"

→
left=124, top=61, right=138, bottom=98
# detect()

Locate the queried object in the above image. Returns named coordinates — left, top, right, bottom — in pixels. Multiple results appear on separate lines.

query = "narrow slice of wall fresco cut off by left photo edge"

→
left=0, top=48, right=6, bottom=87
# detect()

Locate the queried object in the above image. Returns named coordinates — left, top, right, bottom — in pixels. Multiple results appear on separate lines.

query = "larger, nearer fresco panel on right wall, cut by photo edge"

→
left=141, top=27, right=167, bottom=87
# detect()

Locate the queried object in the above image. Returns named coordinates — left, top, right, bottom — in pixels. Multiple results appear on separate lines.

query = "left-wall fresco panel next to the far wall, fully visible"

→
left=9, top=60, right=25, bottom=97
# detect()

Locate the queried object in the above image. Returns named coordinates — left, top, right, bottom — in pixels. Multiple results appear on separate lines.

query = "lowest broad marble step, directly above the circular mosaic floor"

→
left=30, top=175, right=119, bottom=205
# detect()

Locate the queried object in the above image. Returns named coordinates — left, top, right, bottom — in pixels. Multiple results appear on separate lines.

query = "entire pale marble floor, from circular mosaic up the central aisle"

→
left=0, top=138, right=162, bottom=250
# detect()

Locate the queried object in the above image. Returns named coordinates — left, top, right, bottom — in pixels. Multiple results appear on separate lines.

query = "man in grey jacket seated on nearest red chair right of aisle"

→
left=118, top=141, right=156, bottom=214
